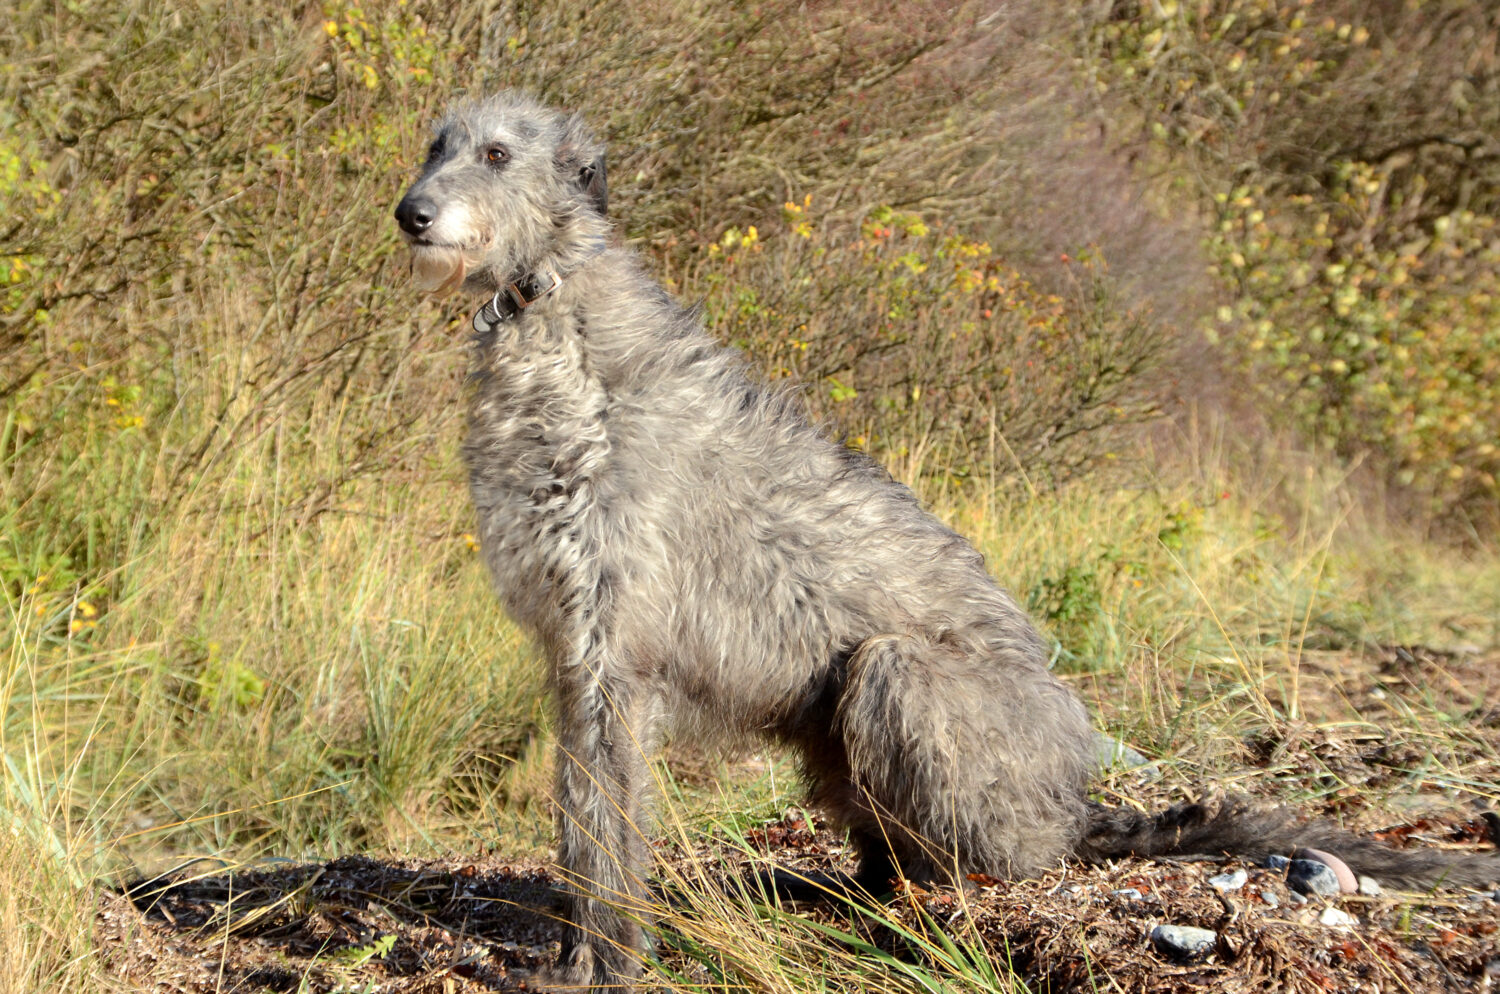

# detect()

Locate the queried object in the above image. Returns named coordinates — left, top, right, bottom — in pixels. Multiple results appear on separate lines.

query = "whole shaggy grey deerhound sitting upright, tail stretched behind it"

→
left=396, top=94, right=1500, bottom=990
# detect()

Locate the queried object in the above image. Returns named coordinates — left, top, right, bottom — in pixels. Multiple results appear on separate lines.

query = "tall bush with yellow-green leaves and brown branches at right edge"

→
left=1092, top=0, right=1500, bottom=520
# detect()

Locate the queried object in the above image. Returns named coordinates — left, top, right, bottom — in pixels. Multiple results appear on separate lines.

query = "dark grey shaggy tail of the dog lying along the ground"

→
left=1077, top=799, right=1500, bottom=888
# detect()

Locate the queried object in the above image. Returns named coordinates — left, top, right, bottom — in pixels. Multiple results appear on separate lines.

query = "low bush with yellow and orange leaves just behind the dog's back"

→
left=698, top=203, right=1167, bottom=486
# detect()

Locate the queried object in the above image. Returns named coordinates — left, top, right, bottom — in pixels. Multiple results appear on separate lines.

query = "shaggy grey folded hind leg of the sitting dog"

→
left=837, top=633, right=1091, bottom=888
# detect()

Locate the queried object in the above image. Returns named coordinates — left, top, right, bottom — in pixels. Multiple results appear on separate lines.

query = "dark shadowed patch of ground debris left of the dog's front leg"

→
left=99, top=856, right=560, bottom=994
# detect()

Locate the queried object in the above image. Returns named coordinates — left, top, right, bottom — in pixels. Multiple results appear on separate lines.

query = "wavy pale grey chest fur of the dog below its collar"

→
left=464, top=325, right=609, bottom=630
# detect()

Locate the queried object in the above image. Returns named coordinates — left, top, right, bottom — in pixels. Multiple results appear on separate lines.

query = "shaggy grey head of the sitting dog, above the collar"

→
left=396, top=93, right=608, bottom=291
